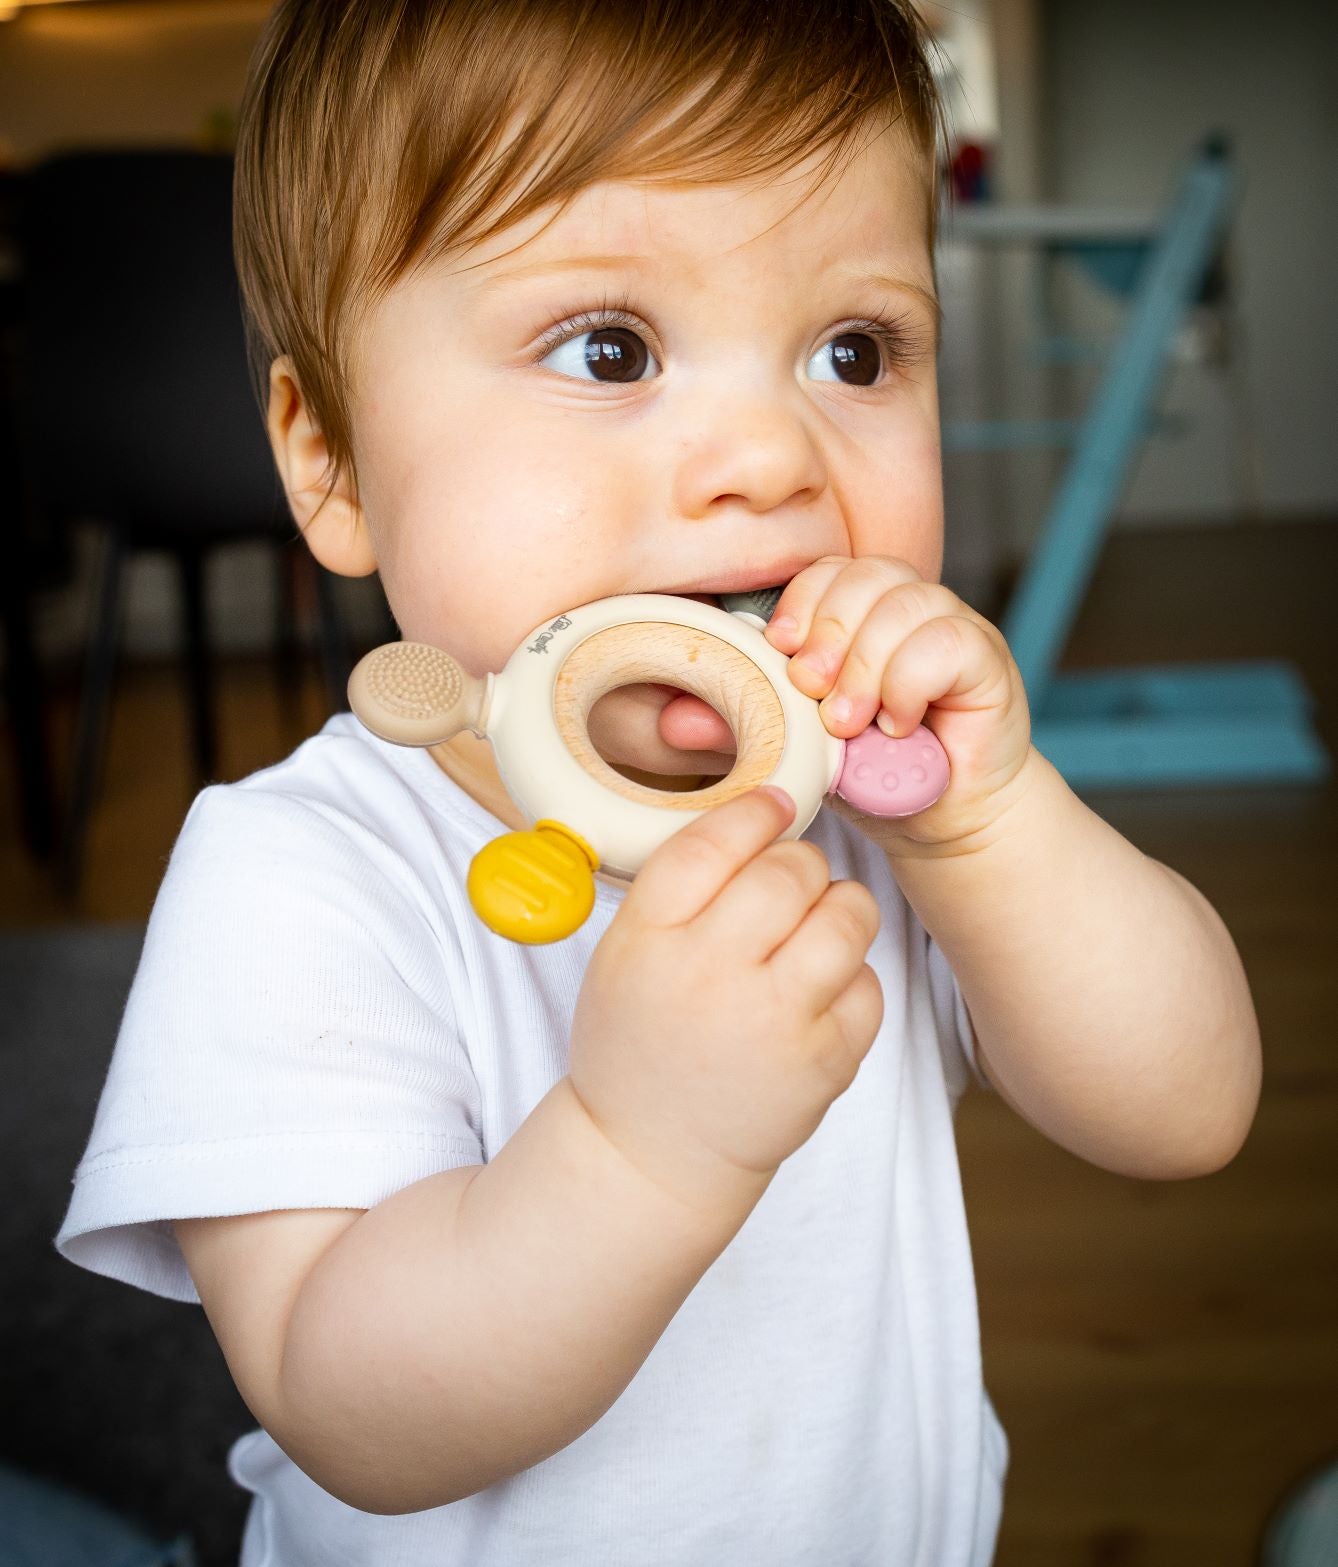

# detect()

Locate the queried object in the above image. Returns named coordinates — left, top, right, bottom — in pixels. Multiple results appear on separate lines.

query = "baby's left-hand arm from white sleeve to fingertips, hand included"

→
left=177, top=791, right=882, bottom=1512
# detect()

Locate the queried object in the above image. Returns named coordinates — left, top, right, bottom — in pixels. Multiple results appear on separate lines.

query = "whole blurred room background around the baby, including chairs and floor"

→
left=0, top=0, right=1338, bottom=1567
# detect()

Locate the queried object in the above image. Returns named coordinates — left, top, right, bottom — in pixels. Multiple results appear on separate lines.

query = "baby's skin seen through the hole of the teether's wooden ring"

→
left=589, top=683, right=735, bottom=788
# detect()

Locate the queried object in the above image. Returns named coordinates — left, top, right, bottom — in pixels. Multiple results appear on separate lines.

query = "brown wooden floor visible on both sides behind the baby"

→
left=0, top=522, right=1338, bottom=1567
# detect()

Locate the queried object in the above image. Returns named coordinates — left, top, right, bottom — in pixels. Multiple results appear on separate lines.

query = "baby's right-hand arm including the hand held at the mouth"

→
left=768, top=556, right=1260, bottom=1178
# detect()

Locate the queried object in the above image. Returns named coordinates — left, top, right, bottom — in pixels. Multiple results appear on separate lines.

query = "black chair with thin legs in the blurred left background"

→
left=17, top=150, right=349, bottom=892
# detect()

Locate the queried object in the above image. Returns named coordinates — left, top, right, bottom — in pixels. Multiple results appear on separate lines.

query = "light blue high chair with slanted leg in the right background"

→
left=945, top=138, right=1330, bottom=788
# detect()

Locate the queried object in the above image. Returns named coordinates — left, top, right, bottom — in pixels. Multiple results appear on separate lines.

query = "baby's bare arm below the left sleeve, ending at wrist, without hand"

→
left=175, top=1078, right=766, bottom=1512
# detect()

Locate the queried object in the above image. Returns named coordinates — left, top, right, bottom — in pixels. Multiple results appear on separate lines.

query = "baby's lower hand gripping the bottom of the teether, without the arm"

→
left=570, top=790, right=882, bottom=1211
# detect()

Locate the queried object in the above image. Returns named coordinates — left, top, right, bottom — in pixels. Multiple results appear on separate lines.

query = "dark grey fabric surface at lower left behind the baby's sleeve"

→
left=0, top=926, right=254, bottom=1567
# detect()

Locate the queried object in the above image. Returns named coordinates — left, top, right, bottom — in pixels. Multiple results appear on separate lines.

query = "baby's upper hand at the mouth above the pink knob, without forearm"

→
left=766, top=555, right=1031, bottom=848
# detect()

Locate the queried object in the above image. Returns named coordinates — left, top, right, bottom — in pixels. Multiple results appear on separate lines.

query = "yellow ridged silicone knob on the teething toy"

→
left=465, top=820, right=600, bottom=946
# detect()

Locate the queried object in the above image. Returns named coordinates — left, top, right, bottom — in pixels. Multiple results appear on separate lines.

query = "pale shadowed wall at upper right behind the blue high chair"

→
left=1042, top=0, right=1338, bottom=519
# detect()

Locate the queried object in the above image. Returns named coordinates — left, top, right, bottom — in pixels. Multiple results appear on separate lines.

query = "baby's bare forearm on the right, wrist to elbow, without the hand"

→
left=891, top=751, right=1260, bottom=1178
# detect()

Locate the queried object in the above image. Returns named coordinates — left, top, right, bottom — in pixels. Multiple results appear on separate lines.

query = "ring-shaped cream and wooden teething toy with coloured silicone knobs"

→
left=348, top=589, right=948, bottom=943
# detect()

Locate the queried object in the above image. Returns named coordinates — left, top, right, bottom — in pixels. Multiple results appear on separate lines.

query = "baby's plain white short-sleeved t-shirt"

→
left=56, top=715, right=1007, bottom=1567
